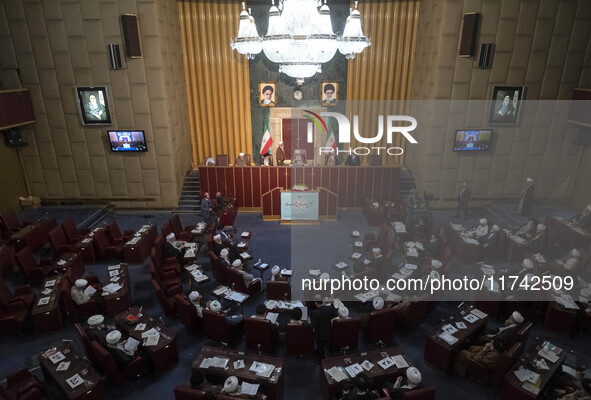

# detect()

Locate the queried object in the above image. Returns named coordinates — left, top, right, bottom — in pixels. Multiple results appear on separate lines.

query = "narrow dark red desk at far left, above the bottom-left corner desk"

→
left=31, top=274, right=64, bottom=333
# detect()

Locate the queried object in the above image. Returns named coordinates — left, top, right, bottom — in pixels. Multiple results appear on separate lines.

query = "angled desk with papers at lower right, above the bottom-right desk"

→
left=425, top=304, right=488, bottom=372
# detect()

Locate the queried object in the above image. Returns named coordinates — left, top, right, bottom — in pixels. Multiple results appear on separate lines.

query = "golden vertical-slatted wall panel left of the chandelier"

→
left=178, top=0, right=252, bottom=165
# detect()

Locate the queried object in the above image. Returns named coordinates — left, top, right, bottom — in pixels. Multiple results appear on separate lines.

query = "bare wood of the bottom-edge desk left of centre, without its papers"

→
left=191, top=346, right=283, bottom=400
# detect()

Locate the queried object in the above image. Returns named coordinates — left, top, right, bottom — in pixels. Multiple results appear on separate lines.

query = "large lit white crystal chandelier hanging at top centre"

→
left=230, top=0, right=371, bottom=79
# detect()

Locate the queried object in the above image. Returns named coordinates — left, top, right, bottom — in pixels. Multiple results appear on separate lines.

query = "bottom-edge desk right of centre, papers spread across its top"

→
left=320, top=347, right=414, bottom=399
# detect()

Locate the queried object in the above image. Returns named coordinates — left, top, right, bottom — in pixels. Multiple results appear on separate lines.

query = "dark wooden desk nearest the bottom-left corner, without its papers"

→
left=39, top=343, right=105, bottom=400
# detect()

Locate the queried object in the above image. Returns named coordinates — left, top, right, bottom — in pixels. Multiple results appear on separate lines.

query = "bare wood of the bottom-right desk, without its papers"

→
left=500, top=339, right=566, bottom=400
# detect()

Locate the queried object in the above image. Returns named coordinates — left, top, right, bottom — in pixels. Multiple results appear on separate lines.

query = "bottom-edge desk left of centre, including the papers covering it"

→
left=191, top=346, right=283, bottom=400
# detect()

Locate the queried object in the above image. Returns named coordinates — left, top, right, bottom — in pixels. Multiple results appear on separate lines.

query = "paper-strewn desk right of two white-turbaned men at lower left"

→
left=114, top=306, right=179, bottom=375
